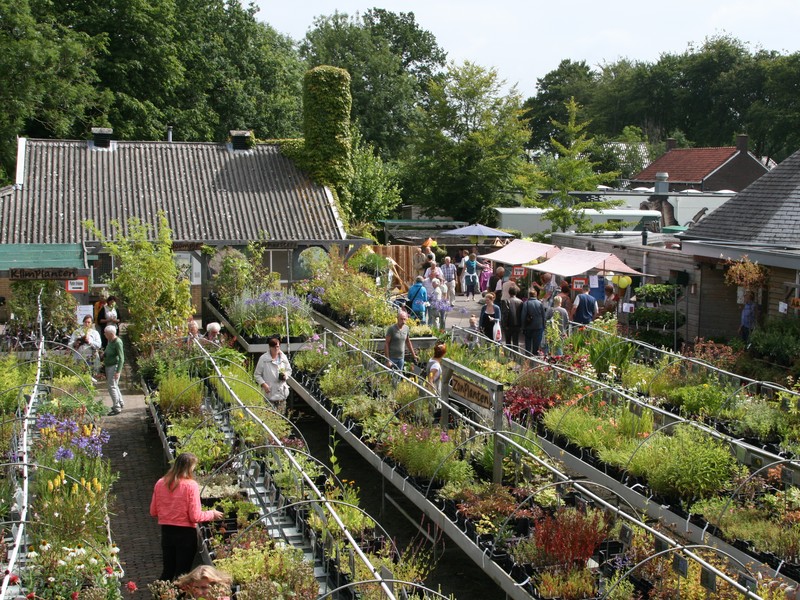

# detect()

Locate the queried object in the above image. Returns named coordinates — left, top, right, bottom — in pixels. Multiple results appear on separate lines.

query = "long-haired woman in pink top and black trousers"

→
left=150, top=452, right=223, bottom=581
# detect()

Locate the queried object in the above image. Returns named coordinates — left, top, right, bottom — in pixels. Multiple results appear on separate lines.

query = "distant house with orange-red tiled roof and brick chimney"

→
left=630, top=135, right=769, bottom=192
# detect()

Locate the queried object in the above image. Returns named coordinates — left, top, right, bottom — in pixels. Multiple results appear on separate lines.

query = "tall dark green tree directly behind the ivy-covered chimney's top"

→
left=300, top=8, right=445, bottom=158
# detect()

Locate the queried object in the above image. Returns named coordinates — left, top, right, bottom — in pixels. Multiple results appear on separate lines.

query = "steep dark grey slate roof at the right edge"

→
left=681, top=151, right=800, bottom=248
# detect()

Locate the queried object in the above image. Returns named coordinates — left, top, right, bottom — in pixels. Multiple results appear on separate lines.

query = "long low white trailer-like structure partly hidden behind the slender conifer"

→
left=495, top=208, right=661, bottom=235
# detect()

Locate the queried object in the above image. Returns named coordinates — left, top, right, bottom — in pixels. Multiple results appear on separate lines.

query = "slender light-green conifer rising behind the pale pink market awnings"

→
left=542, top=98, right=619, bottom=232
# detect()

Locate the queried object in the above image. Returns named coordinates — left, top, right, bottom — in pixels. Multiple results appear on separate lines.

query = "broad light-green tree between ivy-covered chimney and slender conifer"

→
left=401, top=62, right=535, bottom=223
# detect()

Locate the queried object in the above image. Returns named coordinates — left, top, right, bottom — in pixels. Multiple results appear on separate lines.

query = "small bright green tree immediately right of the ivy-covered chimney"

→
left=350, top=131, right=401, bottom=229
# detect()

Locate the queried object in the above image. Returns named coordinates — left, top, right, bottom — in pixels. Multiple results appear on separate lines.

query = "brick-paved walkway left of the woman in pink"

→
left=98, top=369, right=167, bottom=599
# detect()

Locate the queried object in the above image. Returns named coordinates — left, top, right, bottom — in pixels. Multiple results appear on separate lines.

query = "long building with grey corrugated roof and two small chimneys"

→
left=0, top=128, right=356, bottom=316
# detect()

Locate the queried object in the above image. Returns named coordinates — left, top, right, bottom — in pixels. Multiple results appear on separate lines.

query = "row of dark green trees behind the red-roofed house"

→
left=525, top=35, right=800, bottom=160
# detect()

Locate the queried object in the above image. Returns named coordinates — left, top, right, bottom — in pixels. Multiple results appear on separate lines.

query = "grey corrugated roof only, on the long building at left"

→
left=0, top=139, right=345, bottom=244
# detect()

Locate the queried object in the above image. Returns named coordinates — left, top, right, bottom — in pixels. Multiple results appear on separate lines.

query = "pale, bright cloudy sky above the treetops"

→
left=255, top=0, right=800, bottom=98
